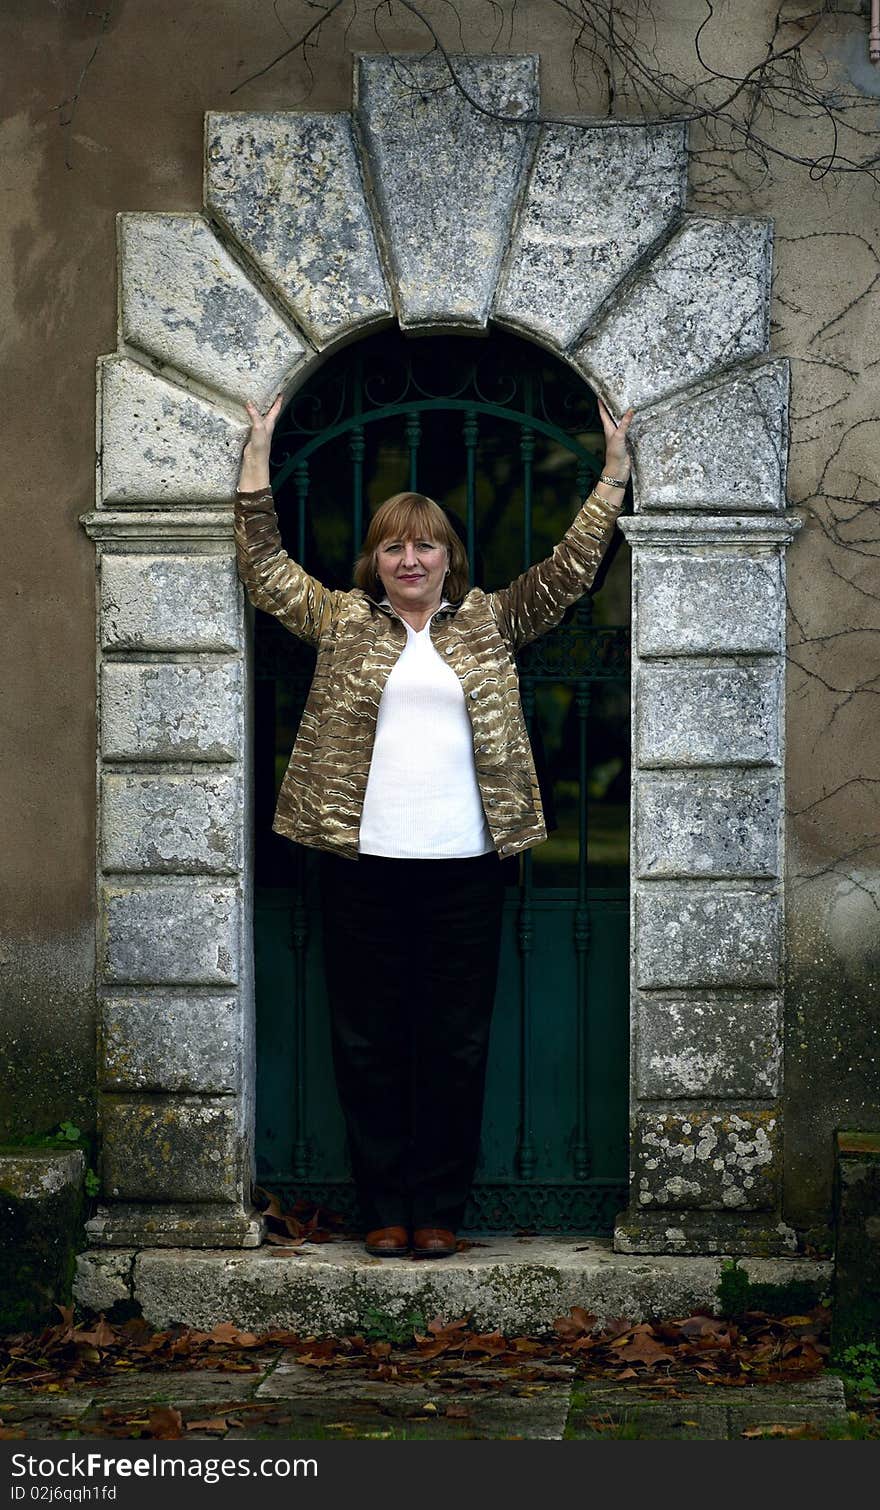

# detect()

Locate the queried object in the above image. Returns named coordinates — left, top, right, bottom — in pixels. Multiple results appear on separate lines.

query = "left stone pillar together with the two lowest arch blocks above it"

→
left=80, top=214, right=314, bottom=1247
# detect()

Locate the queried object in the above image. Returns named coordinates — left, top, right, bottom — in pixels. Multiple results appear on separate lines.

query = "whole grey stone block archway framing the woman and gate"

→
left=82, top=54, right=800, bottom=1253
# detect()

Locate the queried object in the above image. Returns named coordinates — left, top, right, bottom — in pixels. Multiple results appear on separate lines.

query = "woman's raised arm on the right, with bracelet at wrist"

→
left=489, top=399, right=635, bottom=649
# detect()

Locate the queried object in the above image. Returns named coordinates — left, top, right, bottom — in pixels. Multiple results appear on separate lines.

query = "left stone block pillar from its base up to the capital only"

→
left=83, top=507, right=261, bottom=1247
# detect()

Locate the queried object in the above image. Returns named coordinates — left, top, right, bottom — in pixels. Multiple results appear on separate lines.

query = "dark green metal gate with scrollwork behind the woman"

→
left=255, top=331, right=629, bottom=1234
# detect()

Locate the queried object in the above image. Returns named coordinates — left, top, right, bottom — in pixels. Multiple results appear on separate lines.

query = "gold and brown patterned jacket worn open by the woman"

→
left=234, top=489, right=620, bottom=859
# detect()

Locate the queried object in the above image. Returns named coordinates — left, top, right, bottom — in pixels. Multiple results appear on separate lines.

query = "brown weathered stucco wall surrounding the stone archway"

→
left=0, top=0, right=880, bottom=1226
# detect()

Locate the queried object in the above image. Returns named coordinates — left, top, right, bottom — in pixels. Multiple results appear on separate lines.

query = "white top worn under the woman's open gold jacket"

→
left=358, top=607, right=495, bottom=859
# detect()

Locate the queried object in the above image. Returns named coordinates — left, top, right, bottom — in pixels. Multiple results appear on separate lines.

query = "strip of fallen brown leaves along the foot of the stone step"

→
left=0, top=1306, right=869, bottom=1436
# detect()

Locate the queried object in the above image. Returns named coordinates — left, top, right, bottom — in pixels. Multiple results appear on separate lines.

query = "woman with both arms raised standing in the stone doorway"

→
left=234, top=396, right=634, bottom=1258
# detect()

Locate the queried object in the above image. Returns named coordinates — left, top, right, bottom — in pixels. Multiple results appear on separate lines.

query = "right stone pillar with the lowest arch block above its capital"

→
left=614, top=364, right=802, bottom=1253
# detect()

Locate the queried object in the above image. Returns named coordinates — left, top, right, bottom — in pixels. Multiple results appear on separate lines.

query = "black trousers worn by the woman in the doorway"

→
left=320, top=852, right=504, bottom=1231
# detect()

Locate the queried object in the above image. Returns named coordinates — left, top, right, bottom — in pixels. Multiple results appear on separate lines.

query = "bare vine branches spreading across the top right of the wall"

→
left=229, top=0, right=880, bottom=183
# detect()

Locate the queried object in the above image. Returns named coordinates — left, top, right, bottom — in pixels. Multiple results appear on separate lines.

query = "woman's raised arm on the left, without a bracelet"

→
left=232, top=394, right=344, bottom=645
